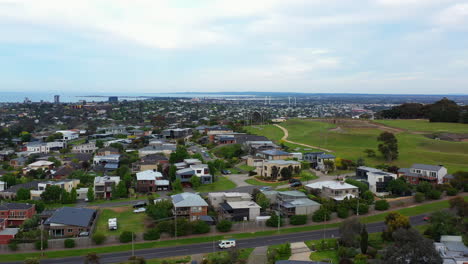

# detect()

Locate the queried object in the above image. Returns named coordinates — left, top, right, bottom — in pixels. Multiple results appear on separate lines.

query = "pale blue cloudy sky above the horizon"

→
left=0, top=0, right=468, bottom=94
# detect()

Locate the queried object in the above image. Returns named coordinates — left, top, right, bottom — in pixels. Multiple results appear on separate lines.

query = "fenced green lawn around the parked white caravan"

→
left=96, top=206, right=147, bottom=236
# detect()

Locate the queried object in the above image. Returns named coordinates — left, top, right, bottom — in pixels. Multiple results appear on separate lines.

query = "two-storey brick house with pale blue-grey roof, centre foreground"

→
left=171, top=192, right=208, bottom=221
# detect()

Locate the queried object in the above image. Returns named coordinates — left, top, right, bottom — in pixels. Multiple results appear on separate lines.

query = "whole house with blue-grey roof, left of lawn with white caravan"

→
left=44, top=207, right=97, bottom=237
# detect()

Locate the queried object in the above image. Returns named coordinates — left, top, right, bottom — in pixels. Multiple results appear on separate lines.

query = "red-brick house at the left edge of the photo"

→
left=0, top=203, right=36, bottom=226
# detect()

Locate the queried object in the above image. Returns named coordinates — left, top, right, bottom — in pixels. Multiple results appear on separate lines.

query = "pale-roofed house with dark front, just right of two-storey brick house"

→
left=218, top=201, right=261, bottom=221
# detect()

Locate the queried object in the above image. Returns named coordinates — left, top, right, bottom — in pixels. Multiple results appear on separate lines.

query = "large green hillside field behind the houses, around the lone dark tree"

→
left=247, top=119, right=468, bottom=173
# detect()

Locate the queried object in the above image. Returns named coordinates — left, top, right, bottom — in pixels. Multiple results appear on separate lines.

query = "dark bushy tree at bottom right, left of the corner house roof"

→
left=383, top=228, right=442, bottom=264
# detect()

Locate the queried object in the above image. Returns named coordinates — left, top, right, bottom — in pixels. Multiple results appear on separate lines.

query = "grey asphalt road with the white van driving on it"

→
left=0, top=215, right=426, bottom=264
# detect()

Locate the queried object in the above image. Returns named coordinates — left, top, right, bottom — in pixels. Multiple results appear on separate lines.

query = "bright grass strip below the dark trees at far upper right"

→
left=374, top=119, right=468, bottom=133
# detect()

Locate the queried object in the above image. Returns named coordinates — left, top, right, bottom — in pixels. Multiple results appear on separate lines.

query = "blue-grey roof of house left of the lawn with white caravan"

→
left=44, top=207, right=96, bottom=227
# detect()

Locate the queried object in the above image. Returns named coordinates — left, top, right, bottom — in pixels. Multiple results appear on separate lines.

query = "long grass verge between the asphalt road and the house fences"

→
left=0, top=196, right=468, bottom=262
